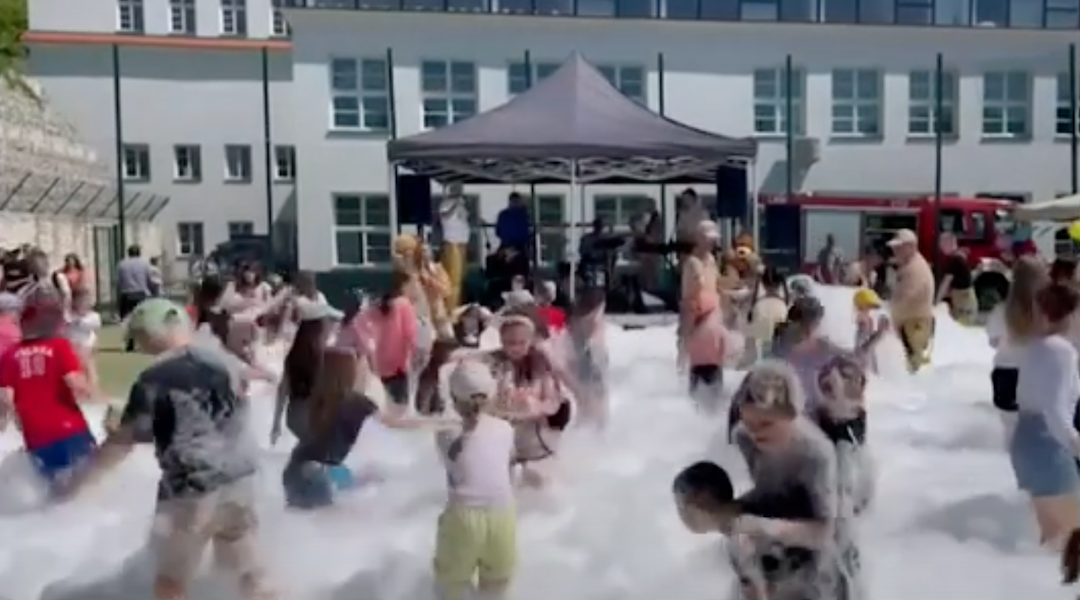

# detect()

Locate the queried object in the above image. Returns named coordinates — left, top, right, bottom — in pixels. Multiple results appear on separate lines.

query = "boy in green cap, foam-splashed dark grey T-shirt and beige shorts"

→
left=59, top=298, right=274, bottom=600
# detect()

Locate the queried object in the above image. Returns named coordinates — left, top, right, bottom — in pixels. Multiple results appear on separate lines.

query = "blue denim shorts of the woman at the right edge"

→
left=1009, top=412, right=1080, bottom=497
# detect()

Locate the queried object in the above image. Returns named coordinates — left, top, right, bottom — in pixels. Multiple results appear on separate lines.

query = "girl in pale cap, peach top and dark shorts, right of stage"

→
left=679, top=220, right=724, bottom=412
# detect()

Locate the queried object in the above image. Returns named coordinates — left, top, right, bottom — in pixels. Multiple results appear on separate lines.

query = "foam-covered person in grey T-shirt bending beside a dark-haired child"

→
left=729, top=363, right=865, bottom=600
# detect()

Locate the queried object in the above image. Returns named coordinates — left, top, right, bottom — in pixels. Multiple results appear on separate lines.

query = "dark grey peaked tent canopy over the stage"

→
left=388, top=54, right=757, bottom=183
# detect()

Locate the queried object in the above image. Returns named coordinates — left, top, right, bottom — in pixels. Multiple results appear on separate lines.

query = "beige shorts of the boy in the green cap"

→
left=154, top=476, right=262, bottom=584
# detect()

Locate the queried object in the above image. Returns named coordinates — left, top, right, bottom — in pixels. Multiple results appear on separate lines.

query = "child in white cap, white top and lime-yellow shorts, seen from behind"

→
left=434, top=360, right=517, bottom=600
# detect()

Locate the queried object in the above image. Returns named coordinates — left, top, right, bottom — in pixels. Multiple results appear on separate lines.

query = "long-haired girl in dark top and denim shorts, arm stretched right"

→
left=282, top=347, right=451, bottom=509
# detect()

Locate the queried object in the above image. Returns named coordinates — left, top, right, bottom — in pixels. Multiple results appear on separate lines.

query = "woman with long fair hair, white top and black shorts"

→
left=986, top=257, right=1049, bottom=445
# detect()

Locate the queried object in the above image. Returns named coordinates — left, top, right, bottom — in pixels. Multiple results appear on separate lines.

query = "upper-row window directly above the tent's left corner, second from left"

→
left=420, top=60, right=477, bottom=128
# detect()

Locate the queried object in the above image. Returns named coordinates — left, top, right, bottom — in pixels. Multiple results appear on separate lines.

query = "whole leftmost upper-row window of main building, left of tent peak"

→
left=330, top=58, right=390, bottom=132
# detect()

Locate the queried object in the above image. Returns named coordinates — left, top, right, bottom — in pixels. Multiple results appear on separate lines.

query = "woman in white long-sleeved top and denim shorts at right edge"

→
left=1009, top=284, right=1080, bottom=549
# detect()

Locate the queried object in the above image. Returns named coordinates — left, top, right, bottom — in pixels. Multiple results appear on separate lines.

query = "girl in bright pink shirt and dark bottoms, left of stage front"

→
left=357, top=271, right=420, bottom=414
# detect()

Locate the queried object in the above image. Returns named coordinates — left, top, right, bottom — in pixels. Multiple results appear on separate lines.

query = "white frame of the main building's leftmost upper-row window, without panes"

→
left=326, top=56, right=394, bottom=134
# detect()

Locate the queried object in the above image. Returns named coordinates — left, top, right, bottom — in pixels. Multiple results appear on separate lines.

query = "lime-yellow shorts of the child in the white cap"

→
left=434, top=506, right=517, bottom=585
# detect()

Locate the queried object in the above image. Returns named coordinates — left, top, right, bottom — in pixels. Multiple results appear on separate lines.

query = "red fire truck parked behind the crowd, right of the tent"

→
left=760, top=194, right=1014, bottom=304
